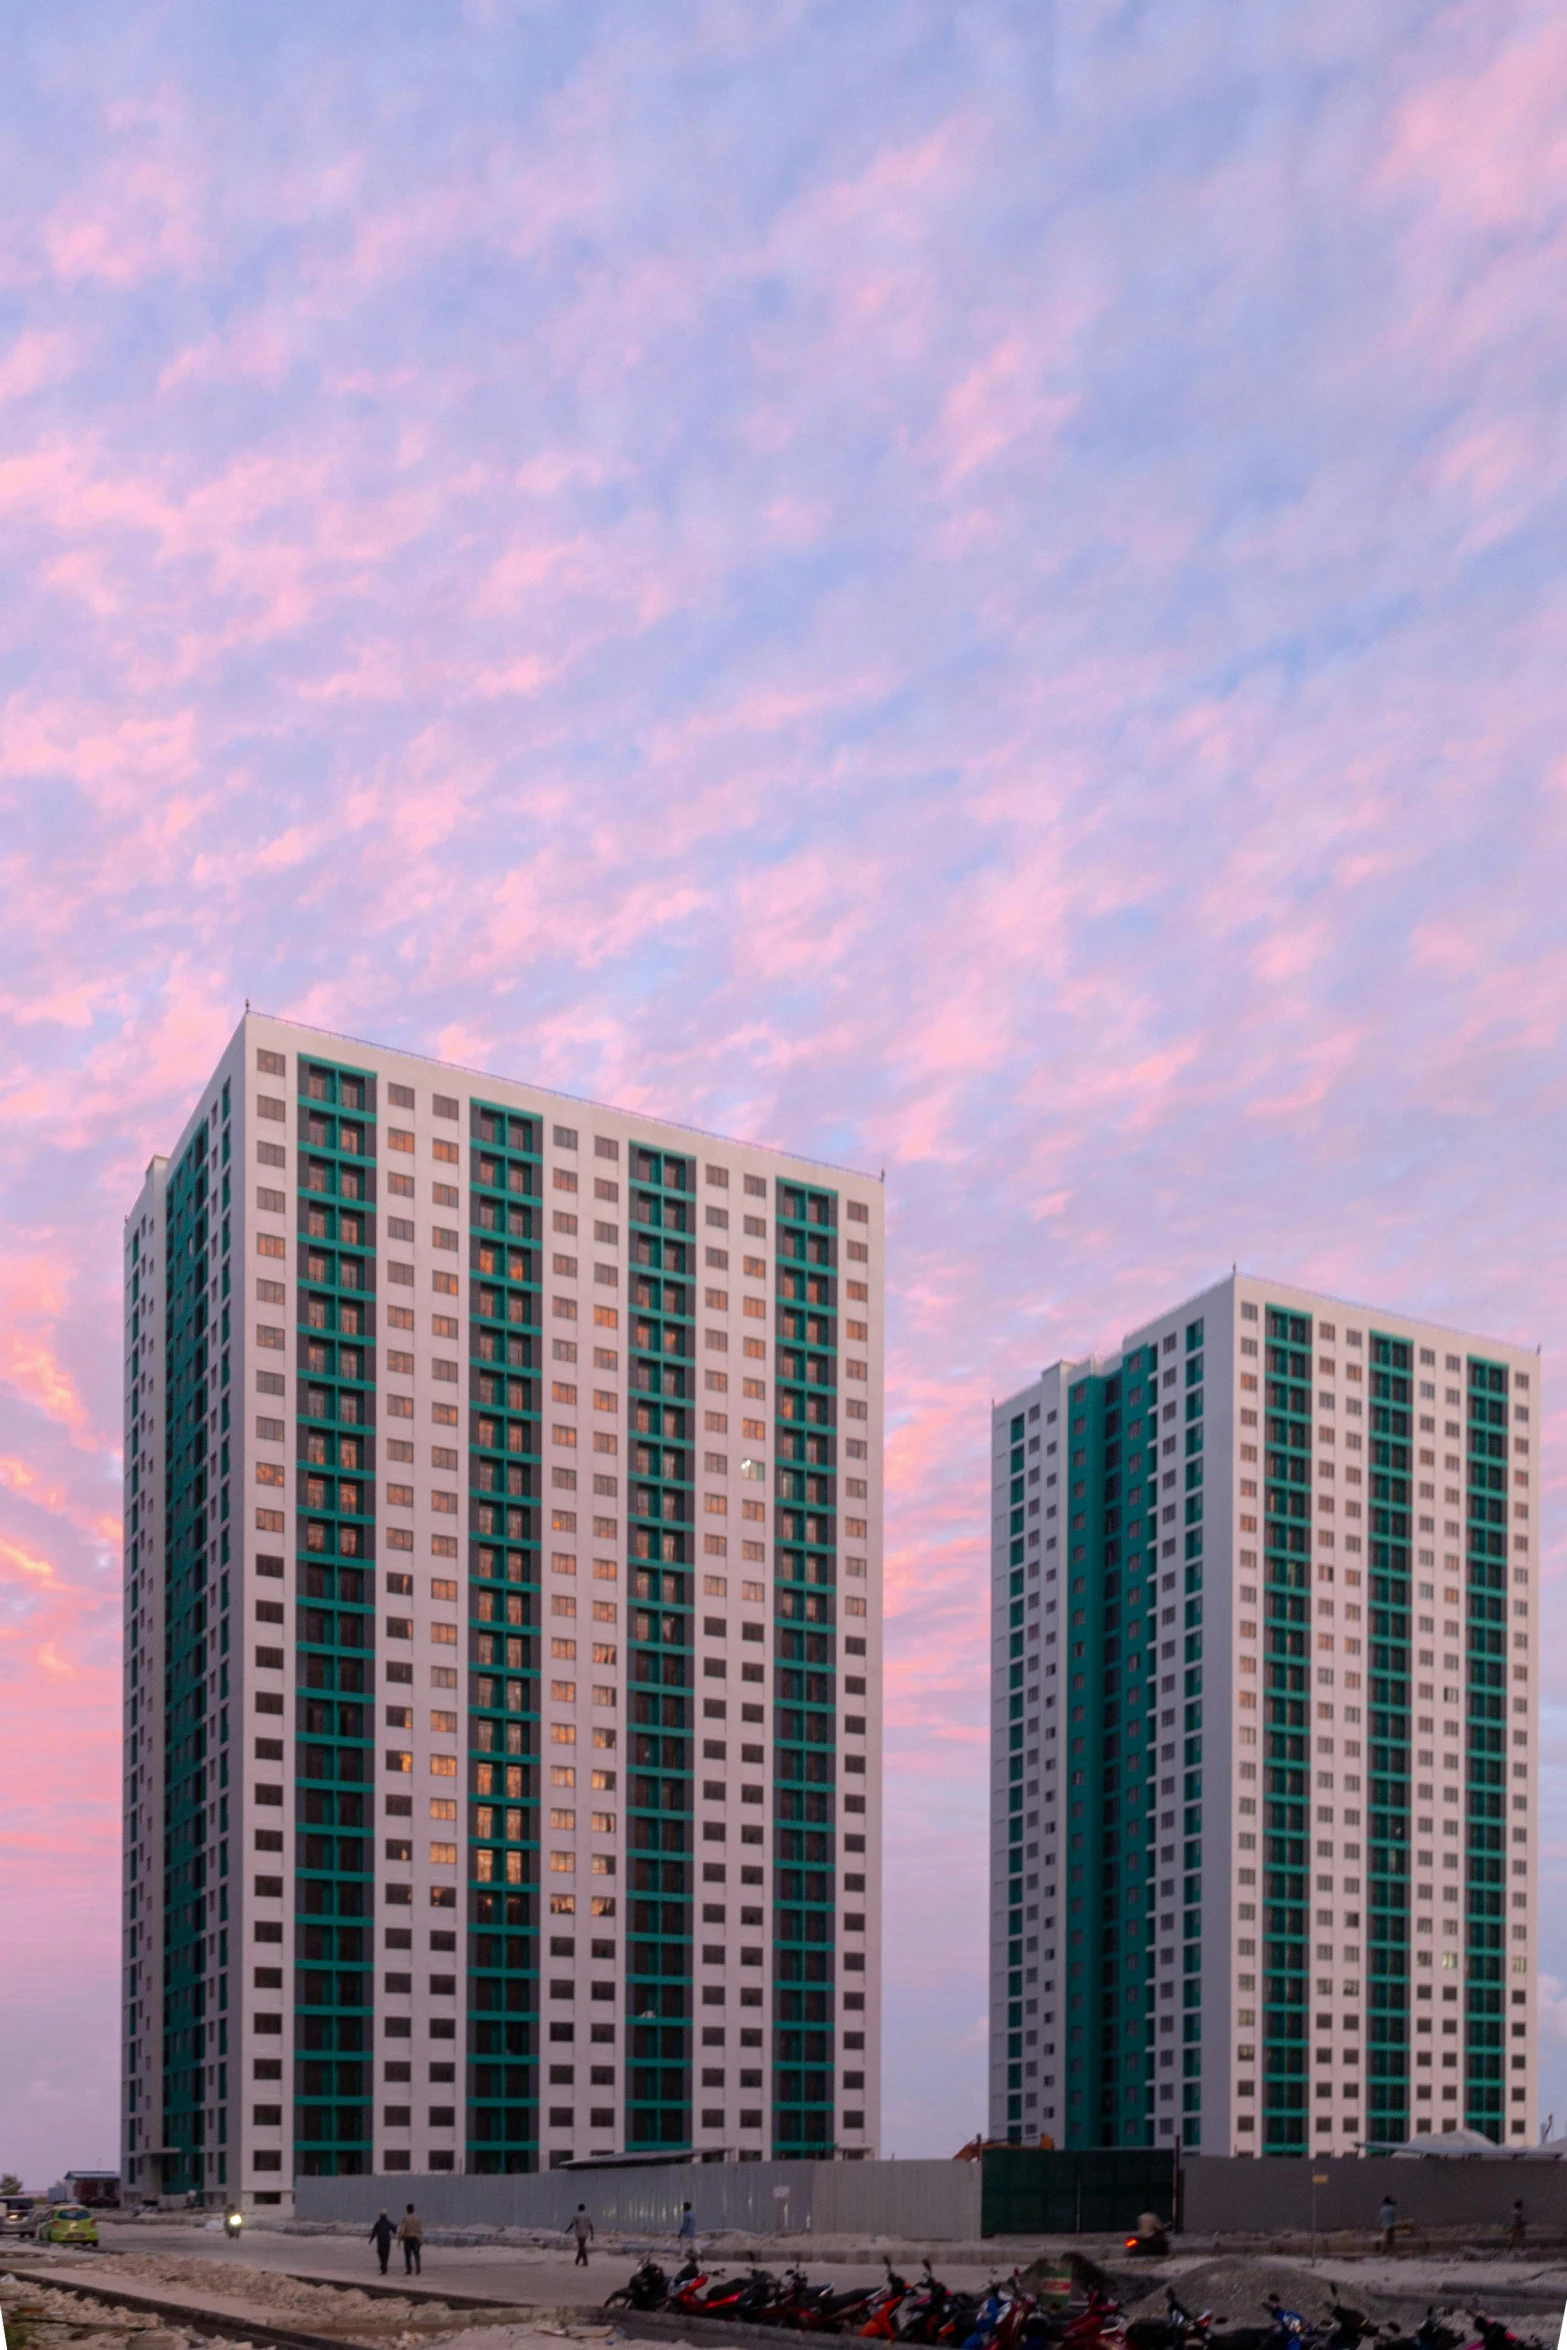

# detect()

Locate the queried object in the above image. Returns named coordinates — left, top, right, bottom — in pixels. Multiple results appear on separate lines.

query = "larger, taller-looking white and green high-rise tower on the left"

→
left=122, top=1015, right=881, bottom=2207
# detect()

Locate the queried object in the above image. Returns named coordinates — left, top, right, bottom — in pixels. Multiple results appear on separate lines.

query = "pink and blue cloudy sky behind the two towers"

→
left=0, top=0, right=1567, bottom=2176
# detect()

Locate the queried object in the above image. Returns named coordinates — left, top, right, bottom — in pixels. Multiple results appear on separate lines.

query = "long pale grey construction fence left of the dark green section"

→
left=294, top=2162, right=980, bottom=2244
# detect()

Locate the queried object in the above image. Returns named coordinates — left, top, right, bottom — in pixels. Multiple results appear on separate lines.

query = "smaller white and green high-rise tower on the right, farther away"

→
left=989, top=1274, right=1541, bottom=2155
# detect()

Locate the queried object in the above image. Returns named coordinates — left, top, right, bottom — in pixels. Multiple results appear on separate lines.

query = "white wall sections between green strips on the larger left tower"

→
left=122, top=1015, right=883, bottom=2207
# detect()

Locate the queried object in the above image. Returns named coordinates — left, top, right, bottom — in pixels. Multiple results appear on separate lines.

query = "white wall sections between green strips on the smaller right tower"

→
left=989, top=1274, right=1544, bottom=2153
